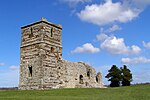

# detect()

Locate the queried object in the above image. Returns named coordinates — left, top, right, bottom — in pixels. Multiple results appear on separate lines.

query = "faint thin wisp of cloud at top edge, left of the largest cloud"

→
left=59, top=0, right=91, bottom=7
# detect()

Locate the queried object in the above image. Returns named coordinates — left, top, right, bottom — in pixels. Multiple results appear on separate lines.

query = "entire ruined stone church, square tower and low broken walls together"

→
left=19, top=18, right=103, bottom=90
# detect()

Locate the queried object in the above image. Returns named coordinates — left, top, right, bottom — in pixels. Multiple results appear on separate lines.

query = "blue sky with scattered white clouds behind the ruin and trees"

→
left=0, top=0, right=150, bottom=87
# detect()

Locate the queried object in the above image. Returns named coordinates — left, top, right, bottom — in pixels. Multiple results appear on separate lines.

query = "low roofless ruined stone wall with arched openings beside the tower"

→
left=58, top=60, right=103, bottom=88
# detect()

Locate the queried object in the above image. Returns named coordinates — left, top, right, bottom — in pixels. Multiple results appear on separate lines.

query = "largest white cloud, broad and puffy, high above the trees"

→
left=77, top=0, right=141, bottom=25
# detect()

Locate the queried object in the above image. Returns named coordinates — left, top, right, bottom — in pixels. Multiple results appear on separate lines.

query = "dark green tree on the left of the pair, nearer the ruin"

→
left=105, top=65, right=122, bottom=87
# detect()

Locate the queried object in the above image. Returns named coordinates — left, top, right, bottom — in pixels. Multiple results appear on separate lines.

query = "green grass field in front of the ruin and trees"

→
left=0, top=85, right=150, bottom=100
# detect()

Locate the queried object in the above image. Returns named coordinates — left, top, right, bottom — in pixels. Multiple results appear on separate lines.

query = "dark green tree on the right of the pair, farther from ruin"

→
left=120, top=65, right=132, bottom=86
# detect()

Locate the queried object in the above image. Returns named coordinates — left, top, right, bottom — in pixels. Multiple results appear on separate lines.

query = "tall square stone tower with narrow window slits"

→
left=19, top=18, right=62, bottom=90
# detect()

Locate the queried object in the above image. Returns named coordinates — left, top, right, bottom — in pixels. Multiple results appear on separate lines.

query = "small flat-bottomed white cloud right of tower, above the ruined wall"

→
left=71, top=43, right=100, bottom=53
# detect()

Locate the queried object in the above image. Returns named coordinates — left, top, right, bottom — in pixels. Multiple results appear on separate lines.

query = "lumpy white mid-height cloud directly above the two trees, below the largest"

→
left=97, top=34, right=141, bottom=55
